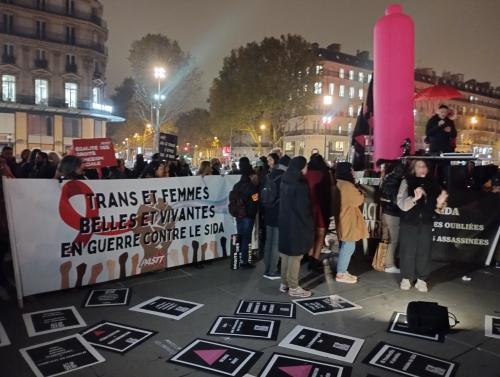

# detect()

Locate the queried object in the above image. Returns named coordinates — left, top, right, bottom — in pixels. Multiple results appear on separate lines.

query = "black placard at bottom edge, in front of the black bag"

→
left=363, top=342, right=458, bottom=377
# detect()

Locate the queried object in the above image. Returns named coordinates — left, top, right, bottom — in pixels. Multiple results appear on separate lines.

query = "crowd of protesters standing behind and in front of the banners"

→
left=0, top=137, right=500, bottom=298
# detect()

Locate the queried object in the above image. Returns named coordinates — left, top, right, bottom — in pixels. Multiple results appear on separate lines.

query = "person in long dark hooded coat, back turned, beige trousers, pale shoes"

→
left=279, top=156, right=314, bottom=297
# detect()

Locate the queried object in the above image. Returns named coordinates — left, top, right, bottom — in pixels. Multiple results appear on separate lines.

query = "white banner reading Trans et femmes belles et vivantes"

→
left=3, top=176, right=239, bottom=298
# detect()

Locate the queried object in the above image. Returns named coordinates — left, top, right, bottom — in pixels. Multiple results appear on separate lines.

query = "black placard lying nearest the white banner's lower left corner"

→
left=23, top=306, right=87, bottom=337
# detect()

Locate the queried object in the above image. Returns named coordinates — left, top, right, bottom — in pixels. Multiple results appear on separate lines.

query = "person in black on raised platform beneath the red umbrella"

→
left=425, top=105, right=457, bottom=154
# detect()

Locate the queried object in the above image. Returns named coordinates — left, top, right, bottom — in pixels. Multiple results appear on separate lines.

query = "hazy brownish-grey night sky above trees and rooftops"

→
left=101, top=0, right=500, bottom=107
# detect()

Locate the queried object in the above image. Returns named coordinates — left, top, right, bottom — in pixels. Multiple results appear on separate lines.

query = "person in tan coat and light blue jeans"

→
left=335, top=162, right=368, bottom=284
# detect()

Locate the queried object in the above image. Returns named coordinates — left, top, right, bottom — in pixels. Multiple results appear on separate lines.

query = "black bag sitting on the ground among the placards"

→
left=406, top=301, right=450, bottom=335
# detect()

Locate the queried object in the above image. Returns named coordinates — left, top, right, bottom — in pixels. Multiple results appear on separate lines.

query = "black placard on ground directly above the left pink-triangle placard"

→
left=208, top=316, right=280, bottom=340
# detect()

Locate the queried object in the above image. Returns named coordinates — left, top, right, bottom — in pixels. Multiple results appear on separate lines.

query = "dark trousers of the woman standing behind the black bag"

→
left=399, top=223, right=432, bottom=281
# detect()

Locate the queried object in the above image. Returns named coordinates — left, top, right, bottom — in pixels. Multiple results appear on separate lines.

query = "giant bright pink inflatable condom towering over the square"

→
left=373, top=4, right=415, bottom=161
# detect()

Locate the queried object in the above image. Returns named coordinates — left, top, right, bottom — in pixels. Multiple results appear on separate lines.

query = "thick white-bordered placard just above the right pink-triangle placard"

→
left=280, top=326, right=364, bottom=363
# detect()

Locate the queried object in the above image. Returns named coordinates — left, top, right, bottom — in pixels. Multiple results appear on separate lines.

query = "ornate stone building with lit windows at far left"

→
left=0, top=0, right=123, bottom=155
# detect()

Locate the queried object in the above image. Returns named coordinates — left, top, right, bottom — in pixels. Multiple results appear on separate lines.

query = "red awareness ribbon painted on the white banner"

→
left=59, top=181, right=130, bottom=245
